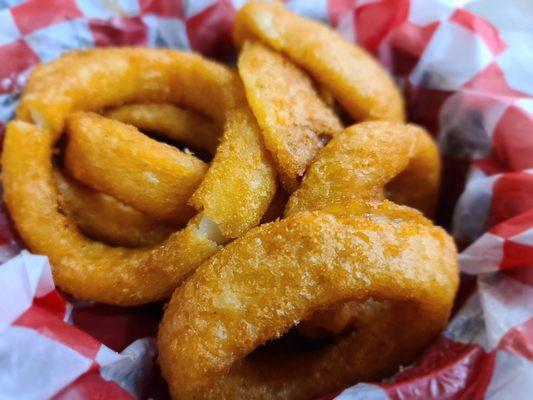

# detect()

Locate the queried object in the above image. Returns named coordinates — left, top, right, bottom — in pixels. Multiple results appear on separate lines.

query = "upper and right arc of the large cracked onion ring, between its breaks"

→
left=16, top=48, right=275, bottom=238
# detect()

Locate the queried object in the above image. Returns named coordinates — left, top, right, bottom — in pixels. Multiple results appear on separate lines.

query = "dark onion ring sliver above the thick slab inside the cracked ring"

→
left=104, top=103, right=221, bottom=155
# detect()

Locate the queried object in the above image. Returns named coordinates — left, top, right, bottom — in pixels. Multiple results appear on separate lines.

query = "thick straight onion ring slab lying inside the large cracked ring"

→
left=65, top=112, right=208, bottom=225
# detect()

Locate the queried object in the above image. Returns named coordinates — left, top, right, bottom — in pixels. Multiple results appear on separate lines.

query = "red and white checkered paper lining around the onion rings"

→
left=0, top=0, right=533, bottom=400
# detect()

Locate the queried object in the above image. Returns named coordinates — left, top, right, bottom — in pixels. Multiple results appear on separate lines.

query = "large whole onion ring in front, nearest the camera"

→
left=158, top=202, right=458, bottom=399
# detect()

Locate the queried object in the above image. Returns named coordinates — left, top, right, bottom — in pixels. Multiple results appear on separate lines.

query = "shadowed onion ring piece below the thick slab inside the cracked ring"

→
left=54, top=169, right=172, bottom=248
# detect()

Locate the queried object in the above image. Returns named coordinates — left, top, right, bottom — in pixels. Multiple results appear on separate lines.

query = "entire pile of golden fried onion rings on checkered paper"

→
left=2, top=3, right=458, bottom=399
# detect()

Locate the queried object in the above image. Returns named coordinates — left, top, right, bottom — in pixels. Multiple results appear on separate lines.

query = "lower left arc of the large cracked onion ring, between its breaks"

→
left=2, top=121, right=218, bottom=305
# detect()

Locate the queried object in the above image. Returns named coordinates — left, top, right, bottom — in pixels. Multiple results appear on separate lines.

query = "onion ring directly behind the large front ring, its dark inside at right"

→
left=285, top=121, right=440, bottom=217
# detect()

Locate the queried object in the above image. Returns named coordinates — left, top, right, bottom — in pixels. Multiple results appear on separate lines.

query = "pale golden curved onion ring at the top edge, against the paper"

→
left=234, top=2, right=405, bottom=121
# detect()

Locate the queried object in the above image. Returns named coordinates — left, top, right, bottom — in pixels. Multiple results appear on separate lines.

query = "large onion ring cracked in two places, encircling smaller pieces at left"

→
left=2, top=48, right=275, bottom=305
